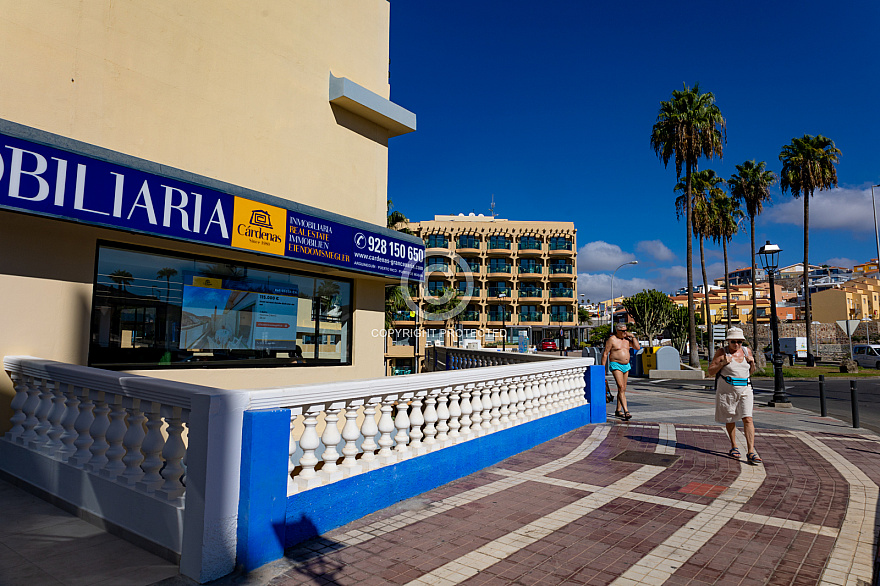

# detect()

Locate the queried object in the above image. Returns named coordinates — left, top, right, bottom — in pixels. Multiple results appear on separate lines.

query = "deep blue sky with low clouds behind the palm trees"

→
left=388, top=0, right=880, bottom=301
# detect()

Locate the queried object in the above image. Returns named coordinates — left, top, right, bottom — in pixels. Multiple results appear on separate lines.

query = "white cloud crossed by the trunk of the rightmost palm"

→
left=761, top=187, right=874, bottom=232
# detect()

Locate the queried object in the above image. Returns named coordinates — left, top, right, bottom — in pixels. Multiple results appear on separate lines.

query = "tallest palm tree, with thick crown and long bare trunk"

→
left=651, top=84, right=726, bottom=367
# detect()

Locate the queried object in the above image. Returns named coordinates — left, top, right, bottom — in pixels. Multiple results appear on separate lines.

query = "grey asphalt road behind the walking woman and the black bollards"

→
left=630, top=378, right=880, bottom=433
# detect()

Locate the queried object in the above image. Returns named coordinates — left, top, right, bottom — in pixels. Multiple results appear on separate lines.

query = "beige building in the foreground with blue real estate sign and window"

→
left=0, top=0, right=424, bottom=426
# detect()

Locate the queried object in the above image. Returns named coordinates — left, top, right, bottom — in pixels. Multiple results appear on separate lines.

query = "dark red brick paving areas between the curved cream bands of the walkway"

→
left=271, top=426, right=880, bottom=586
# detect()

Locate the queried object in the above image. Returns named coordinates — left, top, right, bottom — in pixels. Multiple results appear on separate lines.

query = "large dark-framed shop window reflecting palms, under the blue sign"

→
left=89, top=246, right=351, bottom=369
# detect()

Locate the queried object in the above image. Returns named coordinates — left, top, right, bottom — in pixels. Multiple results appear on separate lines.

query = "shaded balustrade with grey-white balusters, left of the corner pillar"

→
left=4, top=357, right=189, bottom=500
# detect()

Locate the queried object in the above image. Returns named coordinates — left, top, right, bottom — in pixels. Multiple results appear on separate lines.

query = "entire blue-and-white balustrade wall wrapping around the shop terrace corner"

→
left=0, top=357, right=605, bottom=582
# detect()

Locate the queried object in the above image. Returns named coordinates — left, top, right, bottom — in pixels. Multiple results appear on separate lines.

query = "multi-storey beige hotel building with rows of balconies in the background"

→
left=386, top=214, right=578, bottom=373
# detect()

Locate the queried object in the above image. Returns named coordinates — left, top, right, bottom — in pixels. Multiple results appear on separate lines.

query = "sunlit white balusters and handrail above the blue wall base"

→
left=244, top=359, right=586, bottom=494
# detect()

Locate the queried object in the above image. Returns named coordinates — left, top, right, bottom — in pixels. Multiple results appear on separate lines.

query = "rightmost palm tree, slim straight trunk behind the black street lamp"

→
left=779, top=134, right=840, bottom=366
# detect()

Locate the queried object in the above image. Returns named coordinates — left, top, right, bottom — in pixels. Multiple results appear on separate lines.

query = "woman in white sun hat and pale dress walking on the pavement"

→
left=709, top=328, right=762, bottom=464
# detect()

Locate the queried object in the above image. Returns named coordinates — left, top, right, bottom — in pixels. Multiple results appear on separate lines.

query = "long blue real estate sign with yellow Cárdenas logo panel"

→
left=0, top=125, right=425, bottom=281
